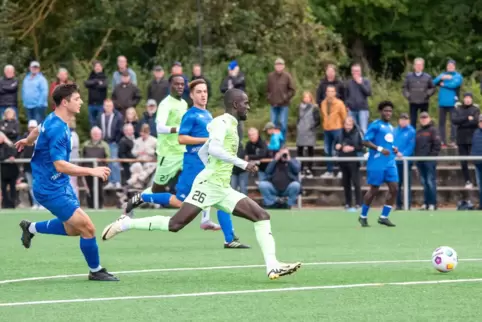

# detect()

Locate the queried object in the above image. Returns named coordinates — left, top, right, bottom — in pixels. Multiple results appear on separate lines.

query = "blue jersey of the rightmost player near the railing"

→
left=364, top=120, right=395, bottom=170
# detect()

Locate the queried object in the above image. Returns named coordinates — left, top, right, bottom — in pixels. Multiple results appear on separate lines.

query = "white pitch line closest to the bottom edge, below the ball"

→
left=0, top=278, right=482, bottom=307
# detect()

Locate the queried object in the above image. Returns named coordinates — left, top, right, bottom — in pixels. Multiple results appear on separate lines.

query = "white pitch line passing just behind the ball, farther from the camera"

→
left=0, top=258, right=482, bottom=285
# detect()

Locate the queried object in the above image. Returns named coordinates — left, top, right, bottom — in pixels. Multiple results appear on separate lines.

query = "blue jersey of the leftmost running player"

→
left=31, top=113, right=72, bottom=196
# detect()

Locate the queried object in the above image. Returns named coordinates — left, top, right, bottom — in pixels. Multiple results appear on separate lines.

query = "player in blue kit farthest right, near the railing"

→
left=358, top=101, right=398, bottom=227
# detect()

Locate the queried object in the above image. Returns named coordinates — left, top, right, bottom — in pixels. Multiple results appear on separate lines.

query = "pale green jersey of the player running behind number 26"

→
left=156, top=95, right=187, bottom=157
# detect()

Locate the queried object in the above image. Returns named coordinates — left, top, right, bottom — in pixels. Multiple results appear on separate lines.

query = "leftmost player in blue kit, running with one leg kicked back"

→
left=15, top=84, right=118, bottom=281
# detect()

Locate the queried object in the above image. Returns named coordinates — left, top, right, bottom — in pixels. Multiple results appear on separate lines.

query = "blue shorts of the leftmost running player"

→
left=33, top=184, right=80, bottom=222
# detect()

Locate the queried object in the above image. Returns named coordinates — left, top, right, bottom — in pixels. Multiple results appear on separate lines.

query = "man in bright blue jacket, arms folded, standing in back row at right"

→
left=433, top=60, right=463, bottom=147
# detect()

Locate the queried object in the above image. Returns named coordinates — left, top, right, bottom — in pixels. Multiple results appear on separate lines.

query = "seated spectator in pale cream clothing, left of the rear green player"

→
left=127, top=124, right=157, bottom=189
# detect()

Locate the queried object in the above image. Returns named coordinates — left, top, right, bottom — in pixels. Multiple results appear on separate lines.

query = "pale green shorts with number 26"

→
left=184, top=178, right=246, bottom=214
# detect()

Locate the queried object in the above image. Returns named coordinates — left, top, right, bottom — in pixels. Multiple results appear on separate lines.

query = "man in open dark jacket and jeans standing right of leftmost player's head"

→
left=97, top=99, right=124, bottom=189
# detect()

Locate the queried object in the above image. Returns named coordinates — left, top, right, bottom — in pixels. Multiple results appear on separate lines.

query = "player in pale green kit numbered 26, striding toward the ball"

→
left=102, top=89, right=301, bottom=279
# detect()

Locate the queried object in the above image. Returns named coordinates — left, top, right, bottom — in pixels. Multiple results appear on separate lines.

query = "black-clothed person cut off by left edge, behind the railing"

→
left=0, top=133, right=19, bottom=208
